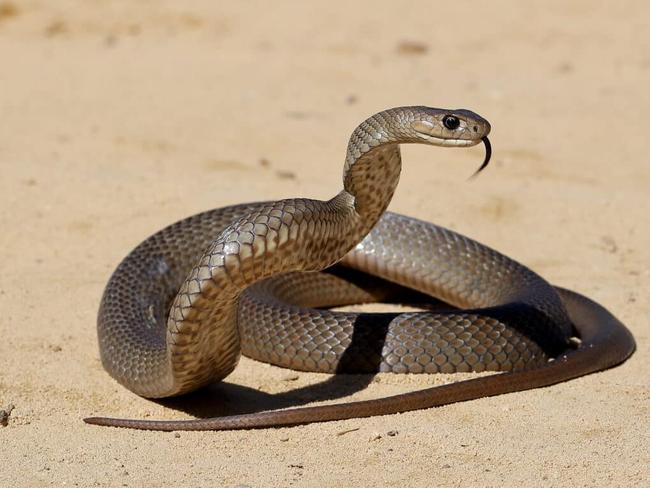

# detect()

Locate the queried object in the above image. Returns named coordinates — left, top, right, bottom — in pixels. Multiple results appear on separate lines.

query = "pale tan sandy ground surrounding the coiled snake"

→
left=0, top=0, right=650, bottom=487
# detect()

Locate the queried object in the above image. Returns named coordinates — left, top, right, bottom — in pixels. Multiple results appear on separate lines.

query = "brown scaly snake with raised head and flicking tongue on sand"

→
left=84, top=106, right=635, bottom=431
